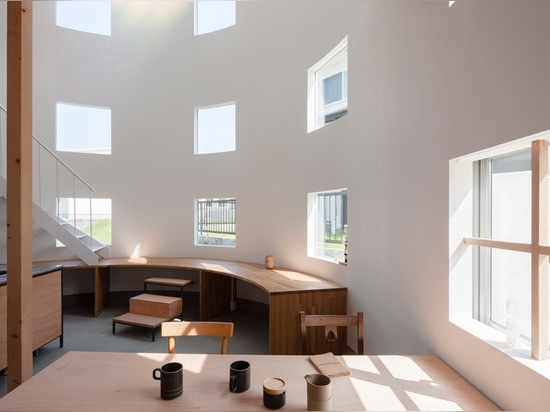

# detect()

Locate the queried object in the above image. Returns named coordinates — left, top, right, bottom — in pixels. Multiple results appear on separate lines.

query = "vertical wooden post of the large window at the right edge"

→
left=531, top=140, right=548, bottom=360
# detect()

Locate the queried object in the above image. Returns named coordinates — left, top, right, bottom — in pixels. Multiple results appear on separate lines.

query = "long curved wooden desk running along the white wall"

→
left=50, top=258, right=347, bottom=355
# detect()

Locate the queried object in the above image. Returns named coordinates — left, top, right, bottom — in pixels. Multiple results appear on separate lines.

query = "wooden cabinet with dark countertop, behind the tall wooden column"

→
left=0, top=268, right=63, bottom=370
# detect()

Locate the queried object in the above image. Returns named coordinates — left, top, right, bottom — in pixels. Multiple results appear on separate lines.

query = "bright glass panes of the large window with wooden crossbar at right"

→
left=474, top=150, right=531, bottom=347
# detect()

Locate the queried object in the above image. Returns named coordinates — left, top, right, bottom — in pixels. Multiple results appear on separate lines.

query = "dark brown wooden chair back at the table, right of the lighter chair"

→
left=300, top=311, right=365, bottom=355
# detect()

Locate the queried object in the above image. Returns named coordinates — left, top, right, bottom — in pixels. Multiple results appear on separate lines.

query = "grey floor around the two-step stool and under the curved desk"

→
left=0, top=292, right=269, bottom=397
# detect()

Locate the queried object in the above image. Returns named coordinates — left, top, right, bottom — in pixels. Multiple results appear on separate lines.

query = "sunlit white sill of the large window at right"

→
left=451, top=319, right=550, bottom=379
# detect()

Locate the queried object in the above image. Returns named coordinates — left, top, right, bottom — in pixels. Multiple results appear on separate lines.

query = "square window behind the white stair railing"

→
left=57, top=197, right=112, bottom=245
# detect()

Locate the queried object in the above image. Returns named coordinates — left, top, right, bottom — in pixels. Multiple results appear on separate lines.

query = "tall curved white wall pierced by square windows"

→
left=1, top=0, right=550, bottom=410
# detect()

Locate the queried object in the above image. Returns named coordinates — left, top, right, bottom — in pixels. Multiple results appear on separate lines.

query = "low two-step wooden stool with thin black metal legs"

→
left=113, top=293, right=182, bottom=342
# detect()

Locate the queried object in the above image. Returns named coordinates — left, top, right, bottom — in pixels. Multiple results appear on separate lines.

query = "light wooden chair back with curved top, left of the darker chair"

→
left=160, top=321, right=233, bottom=355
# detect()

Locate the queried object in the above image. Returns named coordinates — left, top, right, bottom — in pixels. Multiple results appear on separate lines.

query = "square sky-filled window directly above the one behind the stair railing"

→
left=56, top=103, right=111, bottom=155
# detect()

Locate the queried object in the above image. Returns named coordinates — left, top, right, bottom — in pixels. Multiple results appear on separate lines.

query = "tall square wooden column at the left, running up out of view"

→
left=7, top=1, right=33, bottom=391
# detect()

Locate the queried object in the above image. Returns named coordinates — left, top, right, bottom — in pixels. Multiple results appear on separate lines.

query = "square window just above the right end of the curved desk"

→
left=307, top=189, right=348, bottom=263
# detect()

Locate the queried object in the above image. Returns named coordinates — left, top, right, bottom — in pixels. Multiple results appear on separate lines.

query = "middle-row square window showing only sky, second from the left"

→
left=195, top=102, right=236, bottom=154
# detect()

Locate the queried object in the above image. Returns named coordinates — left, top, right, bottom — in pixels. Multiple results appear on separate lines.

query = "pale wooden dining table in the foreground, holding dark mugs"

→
left=0, top=352, right=498, bottom=411
